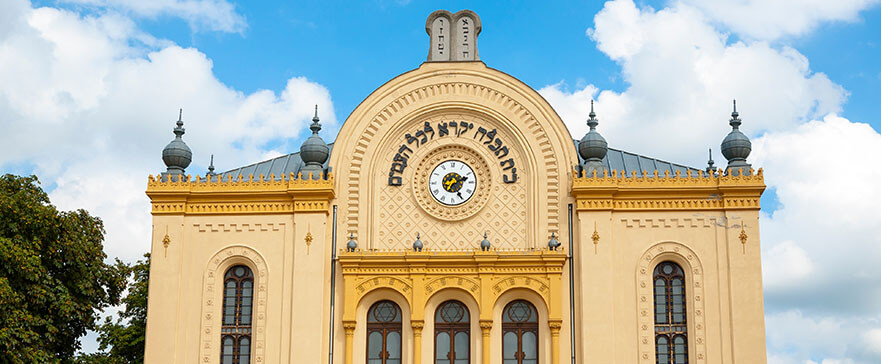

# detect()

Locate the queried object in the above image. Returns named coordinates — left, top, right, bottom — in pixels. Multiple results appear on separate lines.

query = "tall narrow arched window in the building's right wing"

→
left=653, top=262, right=688, bottom=364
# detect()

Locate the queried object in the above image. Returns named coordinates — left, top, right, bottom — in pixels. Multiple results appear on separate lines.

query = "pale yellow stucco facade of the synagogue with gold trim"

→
left=146, top=62, right=766, bottom=364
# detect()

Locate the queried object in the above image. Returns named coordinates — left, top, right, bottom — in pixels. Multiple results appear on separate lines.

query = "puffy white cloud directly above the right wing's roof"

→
left=540, top=0, right=846, bottom=167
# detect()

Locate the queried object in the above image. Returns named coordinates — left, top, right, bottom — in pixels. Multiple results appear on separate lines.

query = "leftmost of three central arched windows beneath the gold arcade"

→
left=367, top=301, right=401, bottom=364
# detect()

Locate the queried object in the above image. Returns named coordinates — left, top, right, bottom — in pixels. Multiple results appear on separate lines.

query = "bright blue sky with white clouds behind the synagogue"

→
left=0, top=0, right=881, bottom=364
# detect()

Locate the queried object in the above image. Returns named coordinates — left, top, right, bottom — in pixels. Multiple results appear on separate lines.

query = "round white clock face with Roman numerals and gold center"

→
left=428, top=160, right=477, bottom=206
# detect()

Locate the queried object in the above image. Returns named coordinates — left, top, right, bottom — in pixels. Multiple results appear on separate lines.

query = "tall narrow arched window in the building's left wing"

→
left=220, top=265, right=254, bottom=364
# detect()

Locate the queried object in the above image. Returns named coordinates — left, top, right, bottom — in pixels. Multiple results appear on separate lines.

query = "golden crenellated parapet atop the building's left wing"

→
left=146, top=173, right=334, bottom=215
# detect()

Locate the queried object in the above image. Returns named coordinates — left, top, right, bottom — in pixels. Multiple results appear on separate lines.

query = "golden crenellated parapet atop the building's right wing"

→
left=571, top=169, right=765, bottom=211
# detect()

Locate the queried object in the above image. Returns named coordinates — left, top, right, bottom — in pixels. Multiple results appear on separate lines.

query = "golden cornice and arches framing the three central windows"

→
left=339, top=248, right=566, bottom=328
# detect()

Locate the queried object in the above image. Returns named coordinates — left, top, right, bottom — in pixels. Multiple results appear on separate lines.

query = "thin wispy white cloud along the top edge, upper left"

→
left=62, top=0, right=247, bottom=33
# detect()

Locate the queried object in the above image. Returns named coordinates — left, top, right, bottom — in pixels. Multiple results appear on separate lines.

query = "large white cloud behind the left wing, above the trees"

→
left=0, top=1, right=337, bottom=268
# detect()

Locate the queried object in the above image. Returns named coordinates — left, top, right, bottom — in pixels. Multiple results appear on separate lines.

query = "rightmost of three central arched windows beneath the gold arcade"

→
left=502, top=300, right=538, bottom=364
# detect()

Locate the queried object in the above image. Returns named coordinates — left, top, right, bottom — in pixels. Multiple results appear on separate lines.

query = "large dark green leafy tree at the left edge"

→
left=0, top=174, right=125, bottom=363
